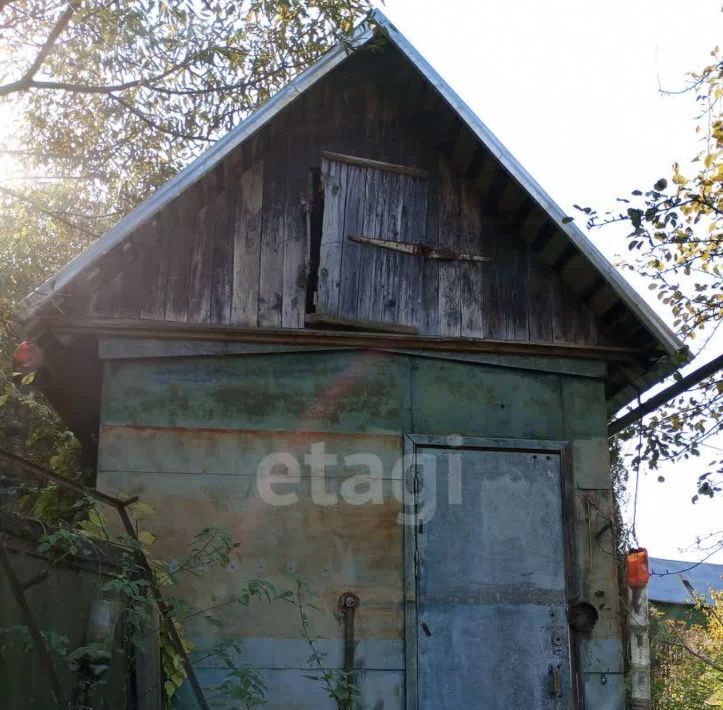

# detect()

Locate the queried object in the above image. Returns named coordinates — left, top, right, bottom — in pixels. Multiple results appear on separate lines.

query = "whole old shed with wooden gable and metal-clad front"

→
left=18, top=13, right=681, bottom=710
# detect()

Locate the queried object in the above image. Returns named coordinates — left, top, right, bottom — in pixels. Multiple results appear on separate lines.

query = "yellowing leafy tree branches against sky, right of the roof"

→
left=578, top=49, right=723, bottom=502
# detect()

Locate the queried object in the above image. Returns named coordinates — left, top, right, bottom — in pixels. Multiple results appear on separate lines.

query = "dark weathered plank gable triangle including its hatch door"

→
left=61, top=41, right=600, bottom=345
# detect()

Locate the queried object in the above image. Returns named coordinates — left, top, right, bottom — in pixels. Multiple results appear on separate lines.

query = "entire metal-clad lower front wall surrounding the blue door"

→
left=98, top=351, right=622, bottom=710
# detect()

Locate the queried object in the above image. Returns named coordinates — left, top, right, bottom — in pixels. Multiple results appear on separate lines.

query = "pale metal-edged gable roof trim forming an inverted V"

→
left=16, top=10, right=683, bottom=406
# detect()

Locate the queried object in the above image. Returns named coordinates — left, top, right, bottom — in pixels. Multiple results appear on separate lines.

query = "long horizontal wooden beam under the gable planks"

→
left=38, top=318, right=640, bottom=362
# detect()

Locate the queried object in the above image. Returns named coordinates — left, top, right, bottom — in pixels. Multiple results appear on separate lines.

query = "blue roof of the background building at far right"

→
left=648, top=557, right=723, bottom=604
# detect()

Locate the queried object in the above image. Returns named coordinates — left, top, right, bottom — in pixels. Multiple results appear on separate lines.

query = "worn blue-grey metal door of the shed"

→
left=415, top=446, right=572, bottom=710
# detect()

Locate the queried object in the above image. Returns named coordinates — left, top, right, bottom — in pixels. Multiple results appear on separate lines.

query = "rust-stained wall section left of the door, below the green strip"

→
left=98, top=426, right=404, bottom=710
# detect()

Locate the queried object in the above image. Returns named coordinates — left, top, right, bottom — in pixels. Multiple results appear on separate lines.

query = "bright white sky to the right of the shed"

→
left=381, top=0, right=723, bottom=564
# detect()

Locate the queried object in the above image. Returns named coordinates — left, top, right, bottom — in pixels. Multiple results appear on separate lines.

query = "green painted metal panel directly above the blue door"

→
left=411, top=359, right=563, bottom=439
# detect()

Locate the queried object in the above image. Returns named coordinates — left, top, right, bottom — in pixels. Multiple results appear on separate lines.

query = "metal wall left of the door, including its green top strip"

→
left=98, top=352, right=409, bottom=710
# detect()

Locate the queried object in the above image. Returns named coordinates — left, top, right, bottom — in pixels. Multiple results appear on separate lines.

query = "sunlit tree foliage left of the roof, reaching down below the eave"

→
left=0, top=0, right=368, bottom=478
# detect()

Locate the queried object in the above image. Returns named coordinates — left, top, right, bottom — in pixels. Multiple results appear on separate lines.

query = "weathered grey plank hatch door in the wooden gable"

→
left=316, top=154, right=427, bottom=325
